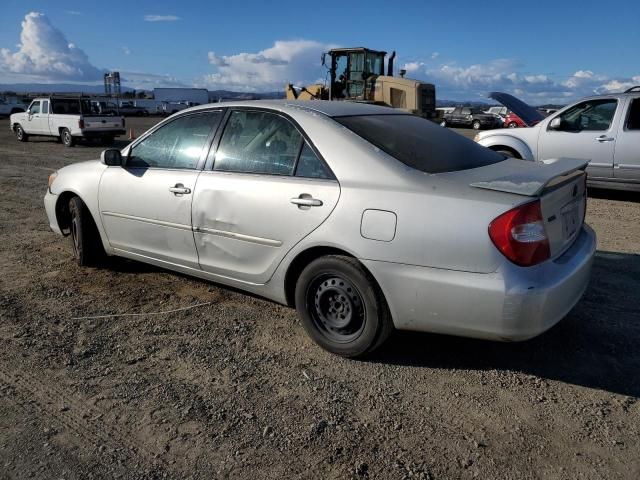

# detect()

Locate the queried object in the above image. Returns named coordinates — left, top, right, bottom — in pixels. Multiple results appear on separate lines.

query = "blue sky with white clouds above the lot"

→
left=0, top=0, right=640, bottom=103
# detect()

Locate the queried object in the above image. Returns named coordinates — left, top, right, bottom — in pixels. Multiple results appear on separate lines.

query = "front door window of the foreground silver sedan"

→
left=127, top=111, right=222, bottom=169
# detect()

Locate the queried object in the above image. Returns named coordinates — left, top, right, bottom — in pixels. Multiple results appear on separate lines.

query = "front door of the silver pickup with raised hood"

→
left=538, top=98, right=621, bottom=178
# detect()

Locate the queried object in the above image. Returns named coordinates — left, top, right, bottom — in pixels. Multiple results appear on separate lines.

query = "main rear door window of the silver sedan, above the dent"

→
left=213, top=110, right=303, bottom=175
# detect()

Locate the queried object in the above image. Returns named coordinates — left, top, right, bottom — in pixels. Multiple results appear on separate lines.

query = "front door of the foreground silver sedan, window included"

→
left=99, top=111, right=222, bottom=268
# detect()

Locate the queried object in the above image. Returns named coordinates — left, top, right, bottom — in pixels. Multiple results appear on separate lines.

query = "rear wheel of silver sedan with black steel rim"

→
left=295, top=255, right=393, bottom=358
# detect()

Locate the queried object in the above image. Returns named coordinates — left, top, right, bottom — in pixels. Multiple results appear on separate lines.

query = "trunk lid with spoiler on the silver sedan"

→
left=465, top=158, right=588, bottom=258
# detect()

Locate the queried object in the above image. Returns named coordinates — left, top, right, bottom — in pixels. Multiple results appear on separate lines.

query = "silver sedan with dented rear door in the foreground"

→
left=44, top=100, right=595, bottom=357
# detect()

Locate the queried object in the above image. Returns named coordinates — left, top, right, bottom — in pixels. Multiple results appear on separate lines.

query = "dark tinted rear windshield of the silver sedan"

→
left=334, top=115, right=504, bottom=173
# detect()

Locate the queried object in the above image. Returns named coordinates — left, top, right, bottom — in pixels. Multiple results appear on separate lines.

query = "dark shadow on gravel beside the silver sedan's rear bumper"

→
left=369, top=251, right=640, bottom=397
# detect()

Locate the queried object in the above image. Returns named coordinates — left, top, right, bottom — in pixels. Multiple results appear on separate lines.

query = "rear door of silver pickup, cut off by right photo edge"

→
left=614, top=97, right=640, bottom=182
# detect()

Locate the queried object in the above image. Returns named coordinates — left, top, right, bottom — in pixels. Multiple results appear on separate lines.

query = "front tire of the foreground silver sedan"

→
left=69, top=197, right=106, bottom=267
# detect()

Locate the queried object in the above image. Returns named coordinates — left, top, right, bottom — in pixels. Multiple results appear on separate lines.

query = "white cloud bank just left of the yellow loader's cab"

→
left=201, top=40, right=335, bottom=91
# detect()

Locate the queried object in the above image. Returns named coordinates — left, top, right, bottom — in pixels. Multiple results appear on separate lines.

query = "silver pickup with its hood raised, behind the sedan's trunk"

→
left=475, top=87, right=640, bottom=191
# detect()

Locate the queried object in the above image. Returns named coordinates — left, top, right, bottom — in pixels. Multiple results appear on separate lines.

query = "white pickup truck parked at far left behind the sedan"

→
left=9, top=97, right=125, bottom=147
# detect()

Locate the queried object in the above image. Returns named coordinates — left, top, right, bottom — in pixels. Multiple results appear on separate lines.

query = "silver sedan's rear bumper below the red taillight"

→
left=362, top=225, right=596, bottom=341
